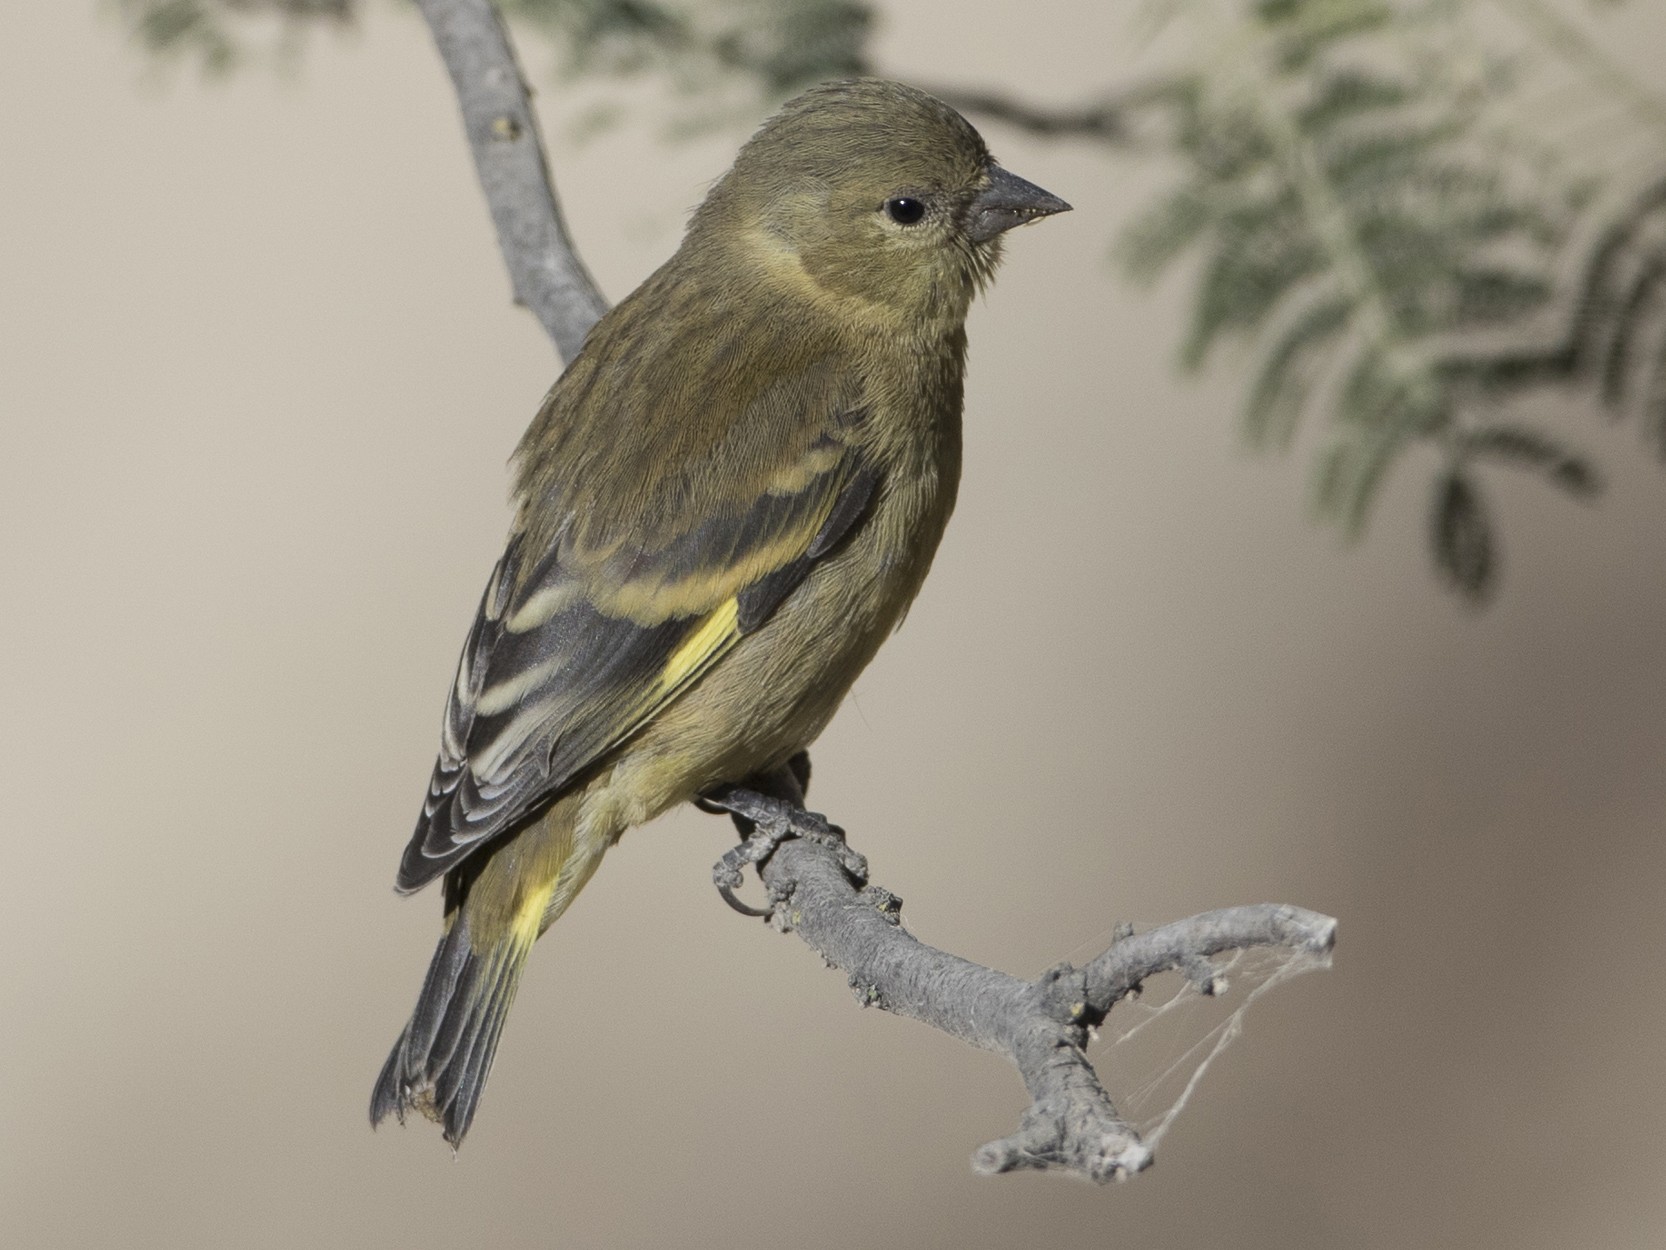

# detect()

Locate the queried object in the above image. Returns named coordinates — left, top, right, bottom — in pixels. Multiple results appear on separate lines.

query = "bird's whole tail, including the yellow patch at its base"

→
left=370, top=803, right=606, bottom=1147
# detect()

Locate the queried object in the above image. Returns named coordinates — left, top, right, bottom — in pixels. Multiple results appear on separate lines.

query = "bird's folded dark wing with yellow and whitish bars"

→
left=398, top=356, right=878, bottom=892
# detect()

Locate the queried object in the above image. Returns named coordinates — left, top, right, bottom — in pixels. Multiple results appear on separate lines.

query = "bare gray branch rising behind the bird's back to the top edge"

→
left=417, top=0, right=608, bottom=360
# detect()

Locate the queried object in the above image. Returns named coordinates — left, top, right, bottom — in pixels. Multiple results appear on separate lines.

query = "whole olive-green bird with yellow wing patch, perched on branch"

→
left=370, top=80, right=1070, bottom=1143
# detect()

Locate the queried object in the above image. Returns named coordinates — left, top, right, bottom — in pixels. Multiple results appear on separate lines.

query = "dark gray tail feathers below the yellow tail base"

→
left=370, top=908, right=536, bottom=1147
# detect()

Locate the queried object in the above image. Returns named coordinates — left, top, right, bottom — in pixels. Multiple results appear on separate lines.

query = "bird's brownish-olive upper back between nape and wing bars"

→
left=515, top=265, right=871, bottom=586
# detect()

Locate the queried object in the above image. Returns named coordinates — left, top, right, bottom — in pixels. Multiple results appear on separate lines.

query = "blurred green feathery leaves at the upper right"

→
left=1120, top=0, right=1666, bottom=600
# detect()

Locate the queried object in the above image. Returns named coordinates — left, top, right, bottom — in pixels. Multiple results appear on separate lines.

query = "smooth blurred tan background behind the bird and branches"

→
left=0, top=0, right=1666, bottom=1250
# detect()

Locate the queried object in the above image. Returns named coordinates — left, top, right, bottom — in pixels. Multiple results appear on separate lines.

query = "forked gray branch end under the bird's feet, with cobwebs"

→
left=710, top=775, right=1336, bottom=1183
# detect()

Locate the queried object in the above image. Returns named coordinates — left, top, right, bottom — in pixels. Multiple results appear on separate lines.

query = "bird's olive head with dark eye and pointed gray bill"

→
left=688, top=78, right=1070, bottom=338
